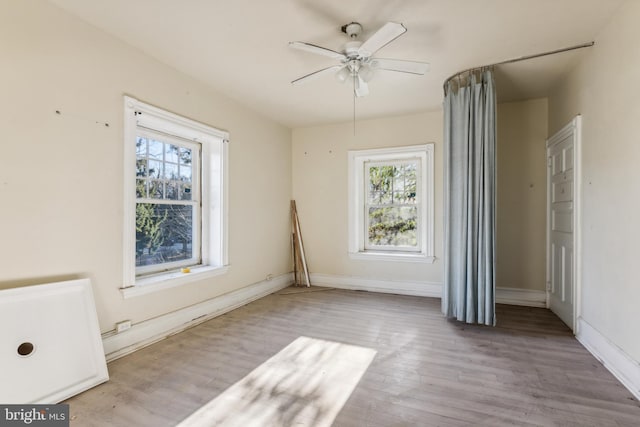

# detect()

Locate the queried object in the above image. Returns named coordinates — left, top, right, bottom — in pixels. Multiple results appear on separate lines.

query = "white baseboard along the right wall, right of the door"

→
left=576, top=317, right=640, bottom=400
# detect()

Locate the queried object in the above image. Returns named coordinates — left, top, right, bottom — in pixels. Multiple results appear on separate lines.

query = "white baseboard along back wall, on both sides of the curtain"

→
left=311, top=273, right=547, bottom=307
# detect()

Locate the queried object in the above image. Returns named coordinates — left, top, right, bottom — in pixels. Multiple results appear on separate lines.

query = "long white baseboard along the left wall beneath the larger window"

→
left=102, top=273, right=293, bottom=361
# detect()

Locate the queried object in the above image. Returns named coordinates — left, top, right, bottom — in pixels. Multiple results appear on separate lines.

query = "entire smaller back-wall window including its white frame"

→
left=349, top=144, right=434, bottom=262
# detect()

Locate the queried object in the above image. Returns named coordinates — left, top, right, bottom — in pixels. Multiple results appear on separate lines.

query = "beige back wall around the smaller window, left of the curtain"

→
left=292, top=112, right=442, bottom=283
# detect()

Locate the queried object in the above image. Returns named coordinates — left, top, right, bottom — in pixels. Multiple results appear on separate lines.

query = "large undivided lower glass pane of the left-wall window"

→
left=136, top=203, right=193, bottom=267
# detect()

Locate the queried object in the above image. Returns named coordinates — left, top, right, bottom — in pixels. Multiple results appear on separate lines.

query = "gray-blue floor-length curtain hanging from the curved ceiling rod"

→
left=442, top=70, right=496, bottom=326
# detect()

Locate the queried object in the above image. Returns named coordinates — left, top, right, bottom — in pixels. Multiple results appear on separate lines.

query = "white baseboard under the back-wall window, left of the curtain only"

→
left=311, top=273, right=442, bottom=298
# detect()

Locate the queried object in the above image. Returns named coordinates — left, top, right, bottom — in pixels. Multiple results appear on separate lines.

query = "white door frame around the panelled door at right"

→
left=545, top=114, right=582, bottom=335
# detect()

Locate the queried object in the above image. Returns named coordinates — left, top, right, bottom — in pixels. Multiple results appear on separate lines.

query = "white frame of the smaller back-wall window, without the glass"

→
left=348, top=143, right=435, bottom=263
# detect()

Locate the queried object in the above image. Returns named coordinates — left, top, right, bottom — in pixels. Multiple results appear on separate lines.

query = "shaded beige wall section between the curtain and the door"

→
left=496, top=98, right=547, bottom=291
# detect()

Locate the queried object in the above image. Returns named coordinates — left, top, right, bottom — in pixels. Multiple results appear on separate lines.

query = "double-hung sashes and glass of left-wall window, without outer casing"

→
left=136, top=132, right=202, bottom=275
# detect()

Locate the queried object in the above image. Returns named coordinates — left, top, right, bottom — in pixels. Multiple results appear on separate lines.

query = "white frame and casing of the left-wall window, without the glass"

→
left=121, top=96, right=229, bottom=298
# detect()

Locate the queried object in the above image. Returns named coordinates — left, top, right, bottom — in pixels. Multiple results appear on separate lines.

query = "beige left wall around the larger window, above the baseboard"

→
left=0, top=0, right=291, bottom=331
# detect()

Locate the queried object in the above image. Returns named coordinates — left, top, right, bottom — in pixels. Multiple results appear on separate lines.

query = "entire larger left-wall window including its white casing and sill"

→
left=123, top=97, right=228, bottom=296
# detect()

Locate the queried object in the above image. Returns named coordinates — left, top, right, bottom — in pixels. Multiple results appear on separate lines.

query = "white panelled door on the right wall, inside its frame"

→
left=547, top=120, right=577, bottom=330
